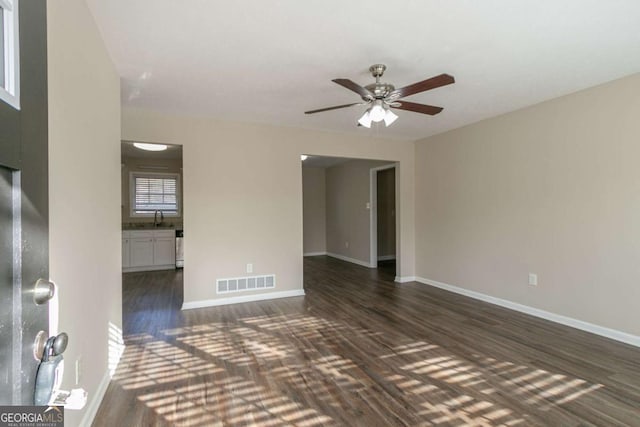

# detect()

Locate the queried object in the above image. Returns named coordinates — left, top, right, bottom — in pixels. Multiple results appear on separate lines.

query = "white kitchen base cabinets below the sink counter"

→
left=122, top=230, right=176, bottom=271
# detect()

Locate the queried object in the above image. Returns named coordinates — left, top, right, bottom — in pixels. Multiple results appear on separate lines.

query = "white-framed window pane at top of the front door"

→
left=0, top=0, right=20, bottom=109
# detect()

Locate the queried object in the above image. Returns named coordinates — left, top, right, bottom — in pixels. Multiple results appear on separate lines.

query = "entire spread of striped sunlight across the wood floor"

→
left=114, top=314, right=602, bottom=427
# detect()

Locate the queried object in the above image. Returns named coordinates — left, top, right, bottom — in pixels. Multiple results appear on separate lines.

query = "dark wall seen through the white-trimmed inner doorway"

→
left=376, top=168, right=396, bottom=259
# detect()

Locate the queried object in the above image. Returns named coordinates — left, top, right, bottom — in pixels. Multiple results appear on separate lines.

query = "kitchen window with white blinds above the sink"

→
left=130, top=172, right=180, bottom=217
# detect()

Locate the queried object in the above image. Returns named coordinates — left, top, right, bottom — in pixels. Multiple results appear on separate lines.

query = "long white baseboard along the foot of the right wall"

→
left=415, top=277, right=640, bottom=347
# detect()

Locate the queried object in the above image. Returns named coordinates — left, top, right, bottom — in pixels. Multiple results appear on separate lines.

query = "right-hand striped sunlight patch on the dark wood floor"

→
left=380, top=342, right=602, bottom=426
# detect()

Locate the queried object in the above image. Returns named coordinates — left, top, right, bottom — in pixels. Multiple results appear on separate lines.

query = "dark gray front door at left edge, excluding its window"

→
left=0, top=0, right=49, bottom=405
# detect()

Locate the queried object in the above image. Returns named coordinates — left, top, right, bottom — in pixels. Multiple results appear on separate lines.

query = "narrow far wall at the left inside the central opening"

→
left=302, top=165, right=327, bottom=254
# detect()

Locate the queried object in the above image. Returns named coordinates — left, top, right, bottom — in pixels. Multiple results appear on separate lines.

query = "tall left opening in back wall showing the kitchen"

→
left=121, top=141, right=185, bottom=334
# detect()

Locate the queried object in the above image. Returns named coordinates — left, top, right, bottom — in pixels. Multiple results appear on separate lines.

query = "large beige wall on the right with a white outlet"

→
left=416, top=75, right=640, bottom=335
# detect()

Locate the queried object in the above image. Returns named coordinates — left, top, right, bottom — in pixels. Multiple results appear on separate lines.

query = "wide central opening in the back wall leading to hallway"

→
left=301, top=155, right=399, bottom=280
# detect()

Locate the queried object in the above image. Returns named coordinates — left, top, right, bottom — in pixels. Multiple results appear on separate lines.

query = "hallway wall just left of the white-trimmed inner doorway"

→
left=326, top=160, right=388, bottom=264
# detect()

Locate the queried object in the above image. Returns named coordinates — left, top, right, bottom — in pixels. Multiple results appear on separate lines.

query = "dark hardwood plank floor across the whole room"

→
left=94, top=257, right=640, bottom=426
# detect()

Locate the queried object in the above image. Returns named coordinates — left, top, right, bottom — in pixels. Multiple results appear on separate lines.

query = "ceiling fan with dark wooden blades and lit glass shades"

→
left=305, top=64, right=455, bottom=128
